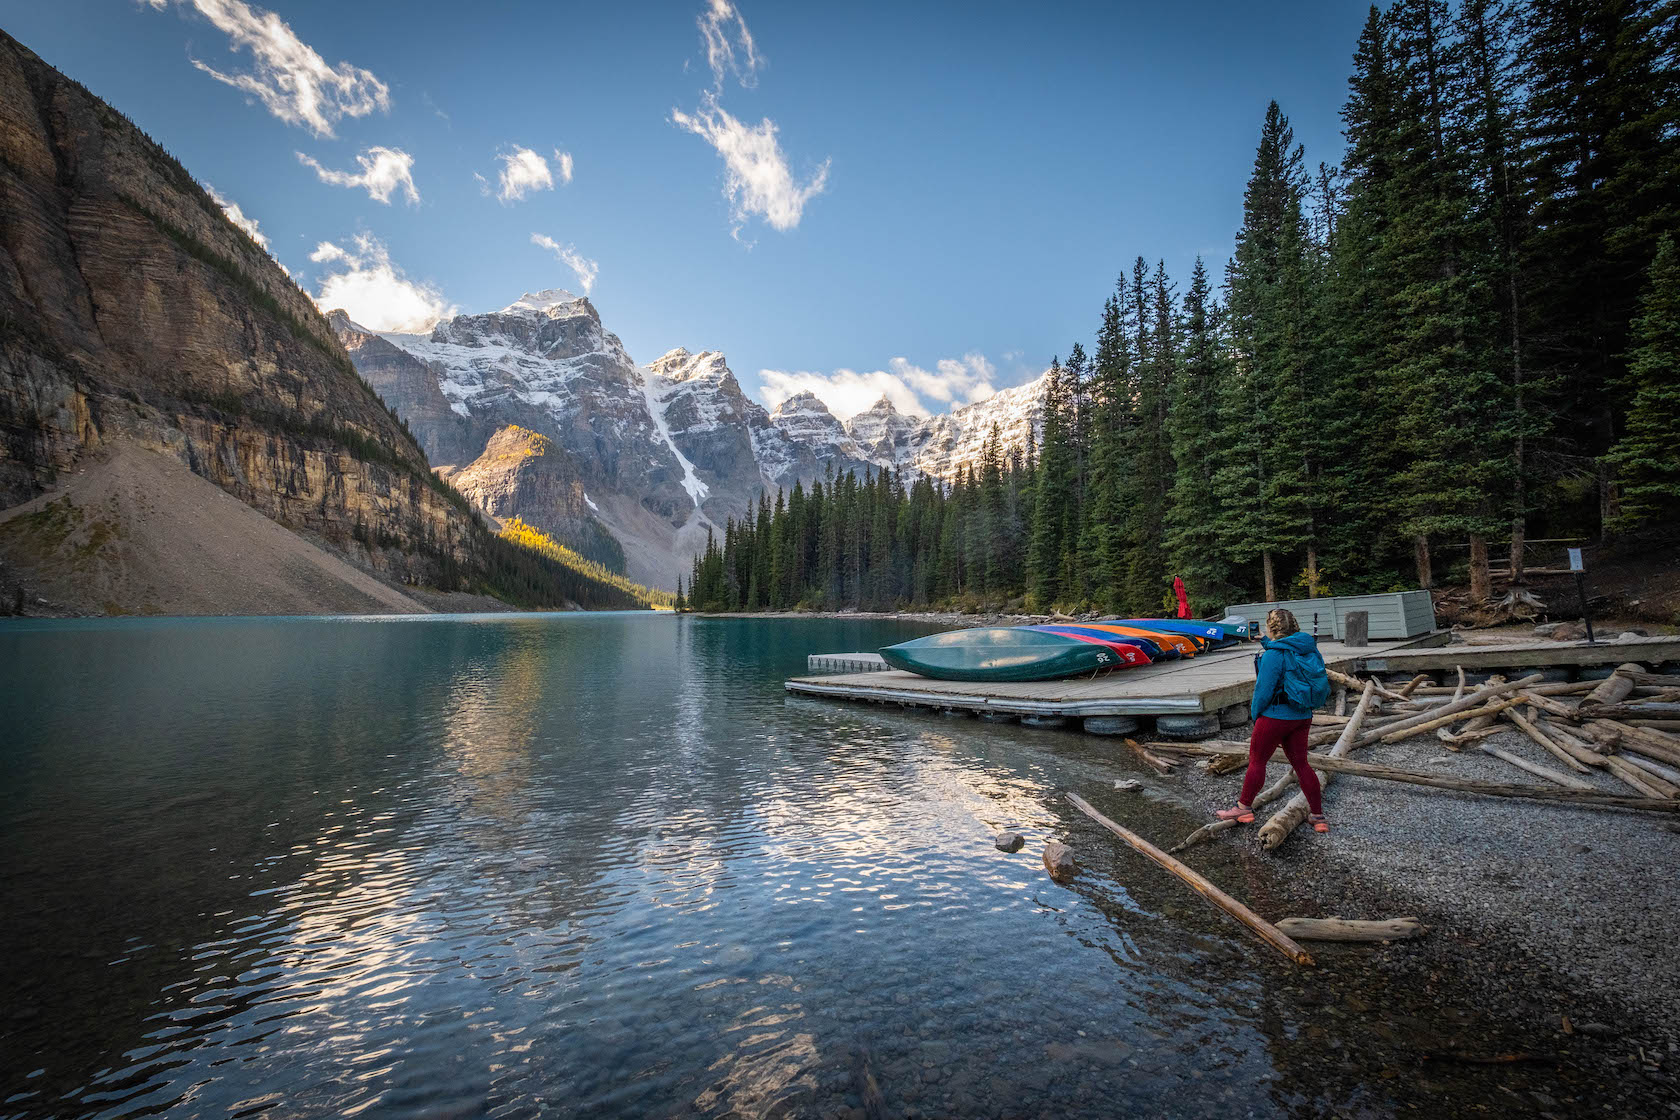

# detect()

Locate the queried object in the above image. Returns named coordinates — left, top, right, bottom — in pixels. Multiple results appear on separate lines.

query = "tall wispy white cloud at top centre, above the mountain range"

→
left=670, top=0, right=830, bottom=240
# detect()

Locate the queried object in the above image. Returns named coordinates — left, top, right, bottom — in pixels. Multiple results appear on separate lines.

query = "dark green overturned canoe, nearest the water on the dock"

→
left=880, top=626, right=1151, bottom=680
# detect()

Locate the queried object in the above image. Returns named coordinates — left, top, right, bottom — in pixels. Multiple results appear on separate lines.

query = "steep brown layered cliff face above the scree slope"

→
left=0, top=32, right=482, bottom=594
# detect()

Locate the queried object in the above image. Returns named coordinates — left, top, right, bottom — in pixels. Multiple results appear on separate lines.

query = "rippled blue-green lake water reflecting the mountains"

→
left=0, top=615, right=1572, bottom=1117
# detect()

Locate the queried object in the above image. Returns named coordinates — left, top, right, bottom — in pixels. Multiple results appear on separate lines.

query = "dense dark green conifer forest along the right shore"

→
left=679, top=0, right=1680, bottom=613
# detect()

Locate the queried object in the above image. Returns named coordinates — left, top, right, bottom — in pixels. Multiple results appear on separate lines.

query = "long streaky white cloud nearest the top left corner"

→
left=146, top=0, right=391, bottom=136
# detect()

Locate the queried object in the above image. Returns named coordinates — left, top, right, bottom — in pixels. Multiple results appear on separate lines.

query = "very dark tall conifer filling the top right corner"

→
left=1520, top=0, right=1680, bottom=521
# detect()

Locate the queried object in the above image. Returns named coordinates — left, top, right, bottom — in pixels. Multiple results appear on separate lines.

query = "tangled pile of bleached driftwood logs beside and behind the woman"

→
left=1147, top=665, right=1680, bottom=853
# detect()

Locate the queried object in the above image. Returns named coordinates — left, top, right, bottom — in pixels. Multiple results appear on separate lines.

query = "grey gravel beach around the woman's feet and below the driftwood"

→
left=1163, top=718, right=1680, bottom=1115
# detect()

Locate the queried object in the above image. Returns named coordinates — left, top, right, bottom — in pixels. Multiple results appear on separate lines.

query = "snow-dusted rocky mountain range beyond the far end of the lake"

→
left=328, top=289, right=1045, bottom=588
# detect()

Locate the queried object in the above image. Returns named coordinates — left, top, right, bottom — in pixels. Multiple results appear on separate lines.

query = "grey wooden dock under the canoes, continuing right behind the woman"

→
left=786, top=631, right=1680, bottom=735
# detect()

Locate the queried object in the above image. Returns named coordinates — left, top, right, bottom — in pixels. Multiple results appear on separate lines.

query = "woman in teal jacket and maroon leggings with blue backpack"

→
left=1215, top=608, right=1331, bottom=833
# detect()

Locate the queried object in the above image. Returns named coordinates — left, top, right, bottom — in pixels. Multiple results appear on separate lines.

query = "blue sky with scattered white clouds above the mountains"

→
left=13, top=0, right=1369, bottom=416
